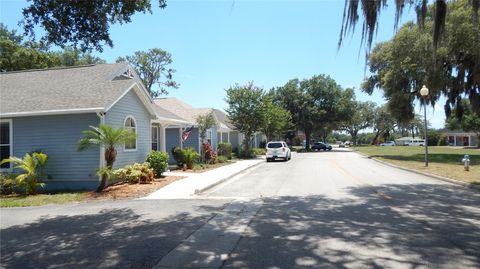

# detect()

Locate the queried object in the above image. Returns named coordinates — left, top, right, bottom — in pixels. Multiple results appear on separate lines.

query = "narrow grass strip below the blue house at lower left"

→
left=0, top=192, right=86, bottom=207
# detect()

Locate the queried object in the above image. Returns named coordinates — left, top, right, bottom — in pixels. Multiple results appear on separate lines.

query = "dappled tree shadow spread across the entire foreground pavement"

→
left=1, top=184, right=480, bottom=268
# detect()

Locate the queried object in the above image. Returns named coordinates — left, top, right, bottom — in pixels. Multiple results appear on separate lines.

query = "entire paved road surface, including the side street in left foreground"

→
left=0, top=149, right=480, bottom=268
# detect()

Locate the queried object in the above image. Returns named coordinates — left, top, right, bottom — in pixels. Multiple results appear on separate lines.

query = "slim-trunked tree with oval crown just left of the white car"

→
left=225, top=82, right=266, bottom=156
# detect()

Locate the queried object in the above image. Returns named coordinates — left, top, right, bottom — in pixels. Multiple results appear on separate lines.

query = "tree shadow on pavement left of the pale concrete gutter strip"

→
left=0, top=203, right=223, bottom=268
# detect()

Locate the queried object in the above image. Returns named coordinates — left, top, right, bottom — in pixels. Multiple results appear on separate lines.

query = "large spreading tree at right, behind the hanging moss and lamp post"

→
left=362, top=0, right=480, bottom=123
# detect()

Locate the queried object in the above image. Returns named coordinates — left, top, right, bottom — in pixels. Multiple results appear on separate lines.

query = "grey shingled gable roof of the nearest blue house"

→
left=0, top=63, right=155, bottom=117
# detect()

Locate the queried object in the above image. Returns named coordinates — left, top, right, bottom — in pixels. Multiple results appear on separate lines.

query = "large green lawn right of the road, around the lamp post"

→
left=352, top=146, right=480, bottom=184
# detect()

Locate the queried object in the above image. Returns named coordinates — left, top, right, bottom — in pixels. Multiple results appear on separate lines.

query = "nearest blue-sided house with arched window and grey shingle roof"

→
left=0, top=63, right=180, bottom=190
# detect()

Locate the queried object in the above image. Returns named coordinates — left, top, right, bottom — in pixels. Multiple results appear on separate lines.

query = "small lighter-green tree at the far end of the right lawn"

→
left=341, top=101, right=376, bottom=145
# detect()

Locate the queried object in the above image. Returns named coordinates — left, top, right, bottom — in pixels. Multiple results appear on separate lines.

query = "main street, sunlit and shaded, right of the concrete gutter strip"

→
left=205, top=149, right=480, bottom=268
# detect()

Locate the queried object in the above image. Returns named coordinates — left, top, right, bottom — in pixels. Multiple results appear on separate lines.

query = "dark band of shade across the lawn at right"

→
left=370, top=153, right=480, bottom=165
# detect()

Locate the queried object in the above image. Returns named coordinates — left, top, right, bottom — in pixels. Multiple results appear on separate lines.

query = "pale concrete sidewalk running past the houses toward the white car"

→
left=141, top=158, right=265, bottom=199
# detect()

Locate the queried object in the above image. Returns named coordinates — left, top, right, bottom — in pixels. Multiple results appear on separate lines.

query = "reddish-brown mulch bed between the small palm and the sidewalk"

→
left=85, top=176, right=185, bottom=200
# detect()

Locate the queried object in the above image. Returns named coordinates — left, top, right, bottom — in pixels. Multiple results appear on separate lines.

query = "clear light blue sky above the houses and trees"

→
left=0, top=0, right=444, bottom=128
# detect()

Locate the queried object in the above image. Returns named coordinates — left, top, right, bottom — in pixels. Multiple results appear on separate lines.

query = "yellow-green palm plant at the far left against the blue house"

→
left=0, top=152, right=48, bottom=194
